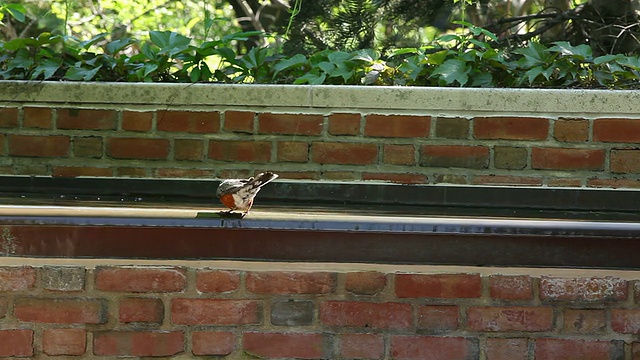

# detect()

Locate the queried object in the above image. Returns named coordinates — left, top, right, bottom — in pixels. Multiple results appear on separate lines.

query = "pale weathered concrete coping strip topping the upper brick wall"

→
left=0, top=81, right=640, bottom=118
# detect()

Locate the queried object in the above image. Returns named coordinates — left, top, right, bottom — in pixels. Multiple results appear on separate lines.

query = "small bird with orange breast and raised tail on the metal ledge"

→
left=216, top=171, right=278, bottom=217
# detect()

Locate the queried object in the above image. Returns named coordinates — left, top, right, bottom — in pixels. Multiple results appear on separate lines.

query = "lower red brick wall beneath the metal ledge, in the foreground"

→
left=0, top=266, right=640, bottom=360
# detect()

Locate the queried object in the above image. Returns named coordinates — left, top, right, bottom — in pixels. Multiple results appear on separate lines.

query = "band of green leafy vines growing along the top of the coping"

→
left=0, top=26, right=640, bottom=88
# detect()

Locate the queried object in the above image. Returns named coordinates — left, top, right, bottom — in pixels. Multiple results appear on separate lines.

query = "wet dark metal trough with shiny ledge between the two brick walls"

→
left=0, top=177, right=640, bottom=269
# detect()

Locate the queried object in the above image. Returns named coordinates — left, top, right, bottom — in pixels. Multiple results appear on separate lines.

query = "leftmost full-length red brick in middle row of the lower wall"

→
left=14, top=297, right=107, bottom=324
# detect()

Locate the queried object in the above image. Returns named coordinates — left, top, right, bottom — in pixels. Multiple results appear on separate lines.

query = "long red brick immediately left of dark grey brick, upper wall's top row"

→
left=364, top=115, right=431, bottom=138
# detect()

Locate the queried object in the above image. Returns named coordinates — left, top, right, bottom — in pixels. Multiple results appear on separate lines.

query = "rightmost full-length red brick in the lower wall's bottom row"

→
left=535, top=339, right=610, bottom=360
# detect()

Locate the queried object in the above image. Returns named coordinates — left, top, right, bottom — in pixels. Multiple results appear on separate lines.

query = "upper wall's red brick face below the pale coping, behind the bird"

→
left=0, top=105, right=640, bottom=187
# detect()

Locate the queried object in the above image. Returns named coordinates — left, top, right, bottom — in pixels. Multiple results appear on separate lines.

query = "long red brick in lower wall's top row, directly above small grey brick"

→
left=245, top=271, right=336, bottom=294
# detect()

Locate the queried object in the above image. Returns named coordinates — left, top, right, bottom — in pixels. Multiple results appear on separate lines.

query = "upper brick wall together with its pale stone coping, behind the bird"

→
left=0, top=81, right=640, bottom=187
